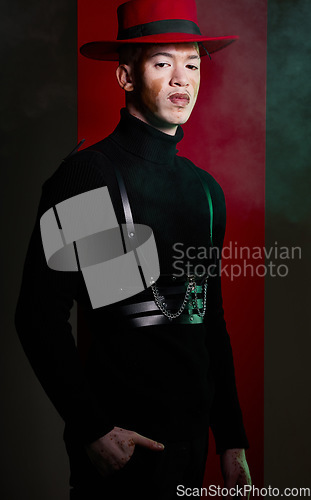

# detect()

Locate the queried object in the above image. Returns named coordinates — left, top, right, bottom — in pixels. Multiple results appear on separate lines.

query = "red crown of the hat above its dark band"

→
left=118, top=0, right=198, bottom=34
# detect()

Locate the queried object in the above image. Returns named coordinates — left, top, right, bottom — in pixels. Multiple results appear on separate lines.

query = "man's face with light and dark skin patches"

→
left=131, top=43, right=200, bottom=133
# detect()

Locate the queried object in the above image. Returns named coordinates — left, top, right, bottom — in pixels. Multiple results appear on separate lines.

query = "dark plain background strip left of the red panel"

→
left=0, top=0, right=77, bottom=500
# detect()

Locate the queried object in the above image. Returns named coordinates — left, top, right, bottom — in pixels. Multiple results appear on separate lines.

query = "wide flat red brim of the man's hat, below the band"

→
left=80, top=33, right=239, bottom=61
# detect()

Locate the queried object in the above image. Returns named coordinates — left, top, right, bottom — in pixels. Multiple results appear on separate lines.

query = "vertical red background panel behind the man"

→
left=78, top=0, right=267, bottom=487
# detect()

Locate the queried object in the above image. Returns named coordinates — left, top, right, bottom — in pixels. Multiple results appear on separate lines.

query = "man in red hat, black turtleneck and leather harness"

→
left=16, top=0, right=250, bottom=500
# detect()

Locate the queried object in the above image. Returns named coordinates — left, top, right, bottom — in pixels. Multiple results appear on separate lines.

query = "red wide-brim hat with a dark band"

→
left=80, top=0, right=239, bottom=61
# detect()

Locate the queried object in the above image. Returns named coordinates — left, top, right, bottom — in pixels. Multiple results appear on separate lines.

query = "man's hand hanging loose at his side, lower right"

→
left=220, top=448, right=252, bottom=499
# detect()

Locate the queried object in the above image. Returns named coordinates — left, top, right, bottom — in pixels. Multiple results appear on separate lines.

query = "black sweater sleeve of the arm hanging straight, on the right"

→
left=204, top=175, right=249, bottom=453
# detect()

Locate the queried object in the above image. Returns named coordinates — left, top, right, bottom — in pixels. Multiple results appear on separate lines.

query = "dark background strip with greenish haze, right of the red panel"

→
left=265, top=0, right=311, bottom=488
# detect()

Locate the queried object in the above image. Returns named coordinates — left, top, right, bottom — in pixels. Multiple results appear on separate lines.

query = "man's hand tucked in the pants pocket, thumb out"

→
left=85, top=427, right=164, bottom=477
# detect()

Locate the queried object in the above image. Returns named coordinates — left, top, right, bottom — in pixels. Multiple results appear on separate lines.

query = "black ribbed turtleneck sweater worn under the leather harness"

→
left=16, top=109, right=248, bottom=452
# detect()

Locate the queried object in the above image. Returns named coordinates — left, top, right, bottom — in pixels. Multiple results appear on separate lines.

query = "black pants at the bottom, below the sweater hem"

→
left=67, top=430, right=208, bottom=500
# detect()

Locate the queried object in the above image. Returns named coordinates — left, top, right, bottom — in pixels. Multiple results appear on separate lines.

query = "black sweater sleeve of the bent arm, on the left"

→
left=15, top=152, right=114, bottom=442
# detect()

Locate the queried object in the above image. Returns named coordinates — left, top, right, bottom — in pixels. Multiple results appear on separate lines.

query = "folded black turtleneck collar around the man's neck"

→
left=110, top=108, right=184, bottom=164
